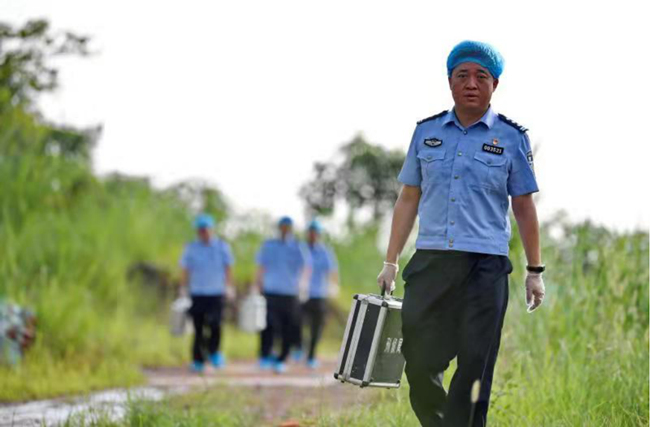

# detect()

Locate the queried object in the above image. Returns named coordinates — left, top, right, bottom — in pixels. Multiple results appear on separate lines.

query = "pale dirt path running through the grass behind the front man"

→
left=0, top=360, right=376, bottom=427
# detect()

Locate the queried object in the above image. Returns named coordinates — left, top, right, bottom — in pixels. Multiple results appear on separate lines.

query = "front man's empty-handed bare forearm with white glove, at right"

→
left=512, top=194, right=545, bottom=312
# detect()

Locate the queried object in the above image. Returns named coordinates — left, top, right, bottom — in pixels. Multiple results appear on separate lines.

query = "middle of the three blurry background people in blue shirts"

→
left=257, top=216, right=311, bottom=373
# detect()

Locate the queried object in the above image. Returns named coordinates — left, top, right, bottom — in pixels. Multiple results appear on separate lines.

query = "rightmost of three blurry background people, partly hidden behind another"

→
left=302, top=220, right=338, bottom=369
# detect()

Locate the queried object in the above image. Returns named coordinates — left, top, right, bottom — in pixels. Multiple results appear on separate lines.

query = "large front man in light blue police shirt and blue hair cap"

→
left=377, top=41, right=545, bottom=426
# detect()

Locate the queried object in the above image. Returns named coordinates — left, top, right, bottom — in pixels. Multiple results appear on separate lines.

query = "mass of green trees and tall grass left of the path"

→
left=0, top=21, right=228, bottom=400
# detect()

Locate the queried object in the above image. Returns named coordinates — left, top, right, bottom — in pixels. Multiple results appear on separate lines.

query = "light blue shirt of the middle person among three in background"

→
left=257, top=237, right=311, bottom=296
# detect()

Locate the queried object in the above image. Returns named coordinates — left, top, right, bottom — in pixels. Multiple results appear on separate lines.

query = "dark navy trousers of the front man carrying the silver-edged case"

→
left=402, top=250, right=512, bottom=427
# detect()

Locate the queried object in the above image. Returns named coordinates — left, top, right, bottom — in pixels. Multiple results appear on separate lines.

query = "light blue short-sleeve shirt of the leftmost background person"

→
left=180, top=238, right=234, bottom=296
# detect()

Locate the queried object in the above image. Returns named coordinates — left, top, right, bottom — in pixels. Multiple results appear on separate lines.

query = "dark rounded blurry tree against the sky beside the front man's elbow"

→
left=300, top=135, right=404, bottom=220
